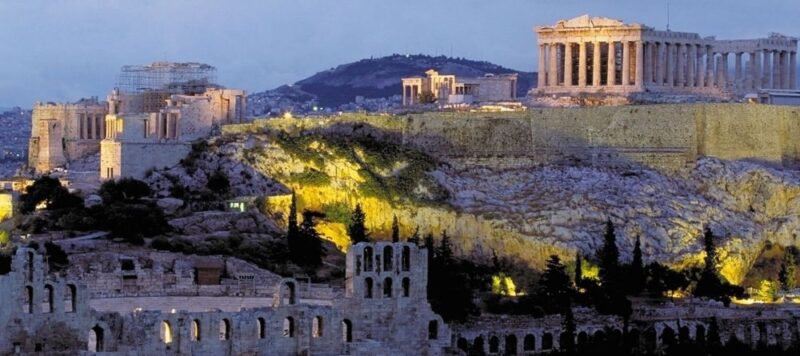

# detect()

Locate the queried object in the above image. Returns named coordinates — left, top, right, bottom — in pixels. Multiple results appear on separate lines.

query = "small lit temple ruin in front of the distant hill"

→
left=402, top=69, right=517, bottom=105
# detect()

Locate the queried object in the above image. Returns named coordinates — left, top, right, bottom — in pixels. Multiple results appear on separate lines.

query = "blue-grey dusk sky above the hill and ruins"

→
left=0, top=0, right=800, bottom=107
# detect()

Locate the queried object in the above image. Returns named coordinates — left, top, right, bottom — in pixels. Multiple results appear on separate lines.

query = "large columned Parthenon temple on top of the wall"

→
left=535, top=15, right=797, bottom=96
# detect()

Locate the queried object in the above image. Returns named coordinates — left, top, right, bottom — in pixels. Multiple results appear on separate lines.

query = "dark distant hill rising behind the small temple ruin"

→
left=249, top=54, right=536, bottom=115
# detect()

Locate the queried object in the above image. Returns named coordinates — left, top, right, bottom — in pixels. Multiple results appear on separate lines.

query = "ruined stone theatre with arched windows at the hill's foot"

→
left=0, top=242, right=451, bottom=355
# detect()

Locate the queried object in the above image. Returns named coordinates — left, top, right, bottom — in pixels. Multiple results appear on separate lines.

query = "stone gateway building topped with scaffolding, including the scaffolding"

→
left=100, top=62, right=246, bottom=179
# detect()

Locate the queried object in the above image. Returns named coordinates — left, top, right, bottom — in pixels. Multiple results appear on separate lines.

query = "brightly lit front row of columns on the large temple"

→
left=539, top=41, right=644, bottom=88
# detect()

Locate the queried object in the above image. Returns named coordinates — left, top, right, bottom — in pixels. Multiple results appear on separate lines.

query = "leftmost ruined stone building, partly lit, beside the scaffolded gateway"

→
left=28, top=98, right=108, bottom=173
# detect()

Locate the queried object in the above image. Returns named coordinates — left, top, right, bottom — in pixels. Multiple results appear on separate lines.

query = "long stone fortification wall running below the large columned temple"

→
left=223, top=104, right=800, bottom=171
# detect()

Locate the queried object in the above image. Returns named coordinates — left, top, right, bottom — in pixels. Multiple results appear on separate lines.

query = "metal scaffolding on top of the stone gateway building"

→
left=116, top=62, right=217, bottom=112
